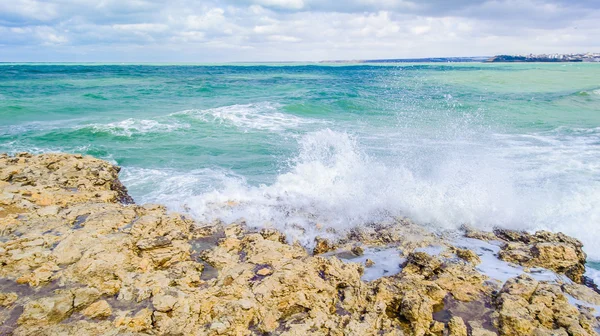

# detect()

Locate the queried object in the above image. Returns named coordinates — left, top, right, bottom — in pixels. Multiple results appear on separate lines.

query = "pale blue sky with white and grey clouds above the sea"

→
left=0, top=0, right=600, bottom=63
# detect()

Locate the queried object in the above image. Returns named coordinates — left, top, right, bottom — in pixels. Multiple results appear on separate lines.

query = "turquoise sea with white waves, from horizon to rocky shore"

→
left=0, top=63, right=600, bottom=260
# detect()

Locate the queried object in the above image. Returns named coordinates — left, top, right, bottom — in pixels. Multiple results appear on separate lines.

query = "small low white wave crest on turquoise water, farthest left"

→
left=76, top=118, right=190, bottom=137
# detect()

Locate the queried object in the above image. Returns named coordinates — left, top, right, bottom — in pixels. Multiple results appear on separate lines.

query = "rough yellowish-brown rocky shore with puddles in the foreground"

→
left=0, top=153, right=600, bottom=336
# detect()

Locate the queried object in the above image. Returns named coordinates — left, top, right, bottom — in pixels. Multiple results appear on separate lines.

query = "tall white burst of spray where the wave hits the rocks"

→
left=164, top=129, right=600, bottom=258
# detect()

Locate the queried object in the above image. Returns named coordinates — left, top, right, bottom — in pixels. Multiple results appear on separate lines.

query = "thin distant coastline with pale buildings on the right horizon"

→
left=320, top=53, right=600, bottom=63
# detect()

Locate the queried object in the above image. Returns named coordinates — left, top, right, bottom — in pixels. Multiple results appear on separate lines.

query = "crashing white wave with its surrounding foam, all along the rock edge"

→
left=116, top=124, right=600, bottom=260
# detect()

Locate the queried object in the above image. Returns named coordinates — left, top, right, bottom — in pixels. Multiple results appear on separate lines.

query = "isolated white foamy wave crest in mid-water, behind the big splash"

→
left=171, top=102, right=320, bottom=131
